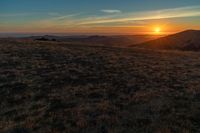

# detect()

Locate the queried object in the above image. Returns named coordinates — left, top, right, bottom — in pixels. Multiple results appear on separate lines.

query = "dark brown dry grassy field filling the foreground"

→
left=0, top=39, right=200, bottom=133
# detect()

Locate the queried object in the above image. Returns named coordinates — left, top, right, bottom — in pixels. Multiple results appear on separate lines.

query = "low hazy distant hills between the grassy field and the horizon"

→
left=25, top=35, right=161, bottom=47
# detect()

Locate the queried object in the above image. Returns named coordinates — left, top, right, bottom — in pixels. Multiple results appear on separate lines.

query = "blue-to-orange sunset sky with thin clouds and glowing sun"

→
left=0, top=0, right=200, bottom=34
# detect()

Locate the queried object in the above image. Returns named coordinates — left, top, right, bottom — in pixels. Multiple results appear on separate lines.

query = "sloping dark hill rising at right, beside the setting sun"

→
left=132, top=30, right=200, bottom=51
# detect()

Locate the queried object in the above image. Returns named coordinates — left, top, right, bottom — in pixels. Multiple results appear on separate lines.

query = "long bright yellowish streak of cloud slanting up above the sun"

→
left=81, top=6, right=200, bottom=25
